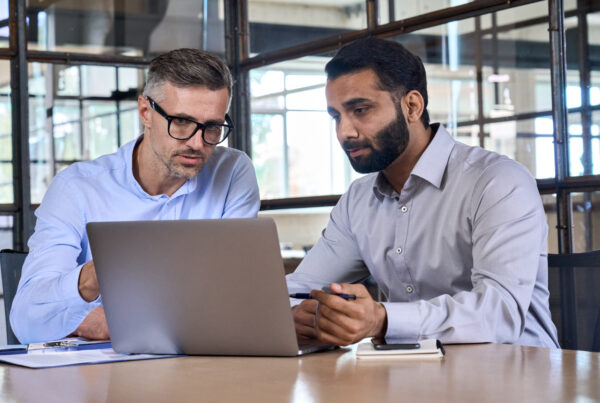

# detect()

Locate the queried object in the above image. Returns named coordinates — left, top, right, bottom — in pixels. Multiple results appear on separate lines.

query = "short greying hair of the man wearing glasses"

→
left=144, top=48, right=233, bottom=101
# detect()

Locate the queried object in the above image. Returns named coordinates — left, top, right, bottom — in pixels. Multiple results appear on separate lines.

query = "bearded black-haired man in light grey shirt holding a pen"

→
left=287, top=38, right=558, bottom=347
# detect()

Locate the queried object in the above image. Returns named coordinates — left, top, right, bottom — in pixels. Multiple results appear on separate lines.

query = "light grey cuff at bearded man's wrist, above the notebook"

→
left=382, top=302, right=422, bottom=341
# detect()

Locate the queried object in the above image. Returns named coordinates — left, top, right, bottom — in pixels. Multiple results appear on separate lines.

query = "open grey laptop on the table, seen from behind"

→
left=87, top=218, right=333, bottom=356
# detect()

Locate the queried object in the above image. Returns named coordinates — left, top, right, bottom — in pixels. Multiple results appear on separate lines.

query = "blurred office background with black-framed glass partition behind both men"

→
left=0, top=0, right=600, bottom=341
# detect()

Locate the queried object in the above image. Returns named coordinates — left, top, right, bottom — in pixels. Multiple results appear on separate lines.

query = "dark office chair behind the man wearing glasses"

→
left=0, top=249, right=27, bottom=344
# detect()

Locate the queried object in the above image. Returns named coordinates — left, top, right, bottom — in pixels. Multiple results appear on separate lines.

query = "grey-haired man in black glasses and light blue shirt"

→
left=11, top=49, right=260, bottom=343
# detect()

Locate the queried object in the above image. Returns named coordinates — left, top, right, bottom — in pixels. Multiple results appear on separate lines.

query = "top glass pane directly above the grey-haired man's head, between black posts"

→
left=24, top=0, right=224, bottom=56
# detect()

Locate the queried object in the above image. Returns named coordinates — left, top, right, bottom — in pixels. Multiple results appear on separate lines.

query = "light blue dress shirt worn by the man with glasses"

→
left=10, top=139, right=260, bottom=343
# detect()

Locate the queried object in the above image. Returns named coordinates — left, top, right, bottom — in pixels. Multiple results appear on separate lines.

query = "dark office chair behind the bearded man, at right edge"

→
left=548, top=251, right=600, bottom=352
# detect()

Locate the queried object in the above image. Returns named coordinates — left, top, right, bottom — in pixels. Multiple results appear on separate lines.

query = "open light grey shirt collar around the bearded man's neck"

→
left=373, top=123, right=454, bottom=200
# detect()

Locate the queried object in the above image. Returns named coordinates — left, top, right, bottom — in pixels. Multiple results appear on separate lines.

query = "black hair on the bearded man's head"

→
left=325, top=38, right=429, bottom=128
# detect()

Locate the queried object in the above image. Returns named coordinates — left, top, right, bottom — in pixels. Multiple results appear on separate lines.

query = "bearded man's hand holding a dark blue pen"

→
left=311, top=283, right=387, bottom=346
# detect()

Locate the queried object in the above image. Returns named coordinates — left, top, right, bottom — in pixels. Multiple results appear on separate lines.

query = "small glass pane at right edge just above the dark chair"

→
left=572, top=191, right=600, bottom=252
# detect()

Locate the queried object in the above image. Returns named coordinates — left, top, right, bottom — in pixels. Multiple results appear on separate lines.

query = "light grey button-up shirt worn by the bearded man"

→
left=287, top=125, right=558, bottom=347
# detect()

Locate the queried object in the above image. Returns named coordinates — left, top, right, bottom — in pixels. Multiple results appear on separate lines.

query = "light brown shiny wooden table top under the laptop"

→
left=0, top=344, right=600, bottom=403
